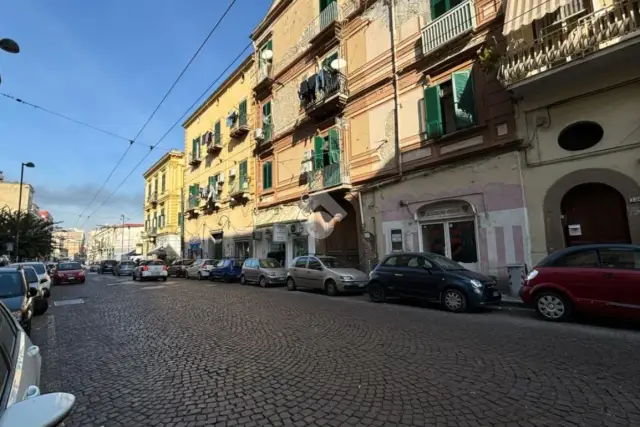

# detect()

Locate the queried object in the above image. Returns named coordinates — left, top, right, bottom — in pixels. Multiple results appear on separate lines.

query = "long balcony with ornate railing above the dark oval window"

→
left=498, top=0, right=640, bottom=86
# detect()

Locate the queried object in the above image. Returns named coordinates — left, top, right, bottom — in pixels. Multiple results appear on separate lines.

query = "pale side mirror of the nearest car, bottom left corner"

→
left=0, top=393, right=76, bottom=427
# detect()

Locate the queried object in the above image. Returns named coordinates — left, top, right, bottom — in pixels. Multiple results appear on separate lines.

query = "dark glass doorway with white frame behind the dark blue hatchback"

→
left=420, top=218, right=479, bottom=271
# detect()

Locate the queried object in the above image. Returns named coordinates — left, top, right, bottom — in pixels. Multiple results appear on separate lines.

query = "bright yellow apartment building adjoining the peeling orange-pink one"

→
left=183, top=56, right=256, bottom=258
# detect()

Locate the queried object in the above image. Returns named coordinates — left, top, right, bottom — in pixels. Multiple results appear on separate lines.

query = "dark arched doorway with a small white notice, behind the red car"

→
left=560, top=182, right=631, bottom=246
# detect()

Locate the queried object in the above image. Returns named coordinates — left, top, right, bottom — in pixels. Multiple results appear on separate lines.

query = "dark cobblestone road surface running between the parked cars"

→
left=28, top=274, right=640, bottom=427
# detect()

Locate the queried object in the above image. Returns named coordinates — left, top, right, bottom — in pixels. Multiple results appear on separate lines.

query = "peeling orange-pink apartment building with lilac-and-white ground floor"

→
left=252, top=0, right=529, bottom=275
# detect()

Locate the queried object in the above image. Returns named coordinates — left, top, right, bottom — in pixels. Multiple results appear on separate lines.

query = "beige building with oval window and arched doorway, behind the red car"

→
left=499, top=0, right=640, bottom=265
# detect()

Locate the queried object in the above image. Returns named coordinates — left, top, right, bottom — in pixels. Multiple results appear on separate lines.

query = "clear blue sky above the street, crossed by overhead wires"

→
left=0, top=0, right=271, bottom=234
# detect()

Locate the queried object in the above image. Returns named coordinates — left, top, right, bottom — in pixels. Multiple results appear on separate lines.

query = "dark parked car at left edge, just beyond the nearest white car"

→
left=0, top=267, right=39, bottom=335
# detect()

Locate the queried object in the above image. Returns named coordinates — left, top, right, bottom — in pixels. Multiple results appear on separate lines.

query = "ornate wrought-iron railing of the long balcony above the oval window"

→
left=499, top=0, right=640, bottom=85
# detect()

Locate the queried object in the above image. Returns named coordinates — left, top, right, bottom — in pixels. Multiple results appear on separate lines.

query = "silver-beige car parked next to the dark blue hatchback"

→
left=287, top=256, right=369, bottom=296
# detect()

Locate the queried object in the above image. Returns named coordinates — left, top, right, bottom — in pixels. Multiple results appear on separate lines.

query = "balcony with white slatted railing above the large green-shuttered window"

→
left=422, top=0, right=476, bottom=55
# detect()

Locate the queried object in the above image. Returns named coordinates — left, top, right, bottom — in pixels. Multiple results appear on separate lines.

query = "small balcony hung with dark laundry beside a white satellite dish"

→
left=301, top=72, right=349, bottom=119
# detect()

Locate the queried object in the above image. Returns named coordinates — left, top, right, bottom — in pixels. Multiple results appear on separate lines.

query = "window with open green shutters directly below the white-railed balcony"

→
left=424, top=70, right=476, bottom=138
